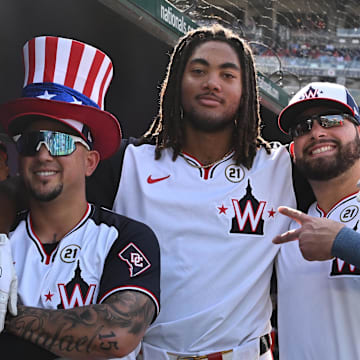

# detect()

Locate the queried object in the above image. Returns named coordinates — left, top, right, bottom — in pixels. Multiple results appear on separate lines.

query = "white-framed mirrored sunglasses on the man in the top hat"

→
left=13, top=130, right=90, bottom=156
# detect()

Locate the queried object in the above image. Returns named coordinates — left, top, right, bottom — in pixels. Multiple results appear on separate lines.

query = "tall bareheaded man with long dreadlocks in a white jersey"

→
left=85, top=26, right=296, bottom=360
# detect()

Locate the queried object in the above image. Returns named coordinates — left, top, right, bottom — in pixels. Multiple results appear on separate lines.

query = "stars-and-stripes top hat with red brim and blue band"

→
left=0, top=36, right=121, bottom=159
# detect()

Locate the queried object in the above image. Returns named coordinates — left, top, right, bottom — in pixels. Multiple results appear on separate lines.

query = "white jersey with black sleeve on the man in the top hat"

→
left=10, top=205, right=160, bottom=359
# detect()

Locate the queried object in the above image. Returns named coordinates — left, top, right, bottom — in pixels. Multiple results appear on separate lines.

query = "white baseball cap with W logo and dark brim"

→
left=278, top=82, right=360, bottom=134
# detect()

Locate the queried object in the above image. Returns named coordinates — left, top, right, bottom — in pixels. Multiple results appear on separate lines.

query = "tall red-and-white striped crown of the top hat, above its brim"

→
left=23, top=36, right=113, bottom=110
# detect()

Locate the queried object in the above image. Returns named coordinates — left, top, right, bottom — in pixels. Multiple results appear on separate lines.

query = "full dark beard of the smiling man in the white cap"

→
left=295, top=135, right=360, bottom=181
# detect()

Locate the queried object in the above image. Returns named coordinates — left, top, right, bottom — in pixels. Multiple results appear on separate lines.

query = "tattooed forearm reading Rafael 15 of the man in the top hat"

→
left=6, top=291, right=155, bottom=359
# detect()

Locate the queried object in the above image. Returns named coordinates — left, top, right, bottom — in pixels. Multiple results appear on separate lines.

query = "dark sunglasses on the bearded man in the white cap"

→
left=289, top=114, right=359, bottom=138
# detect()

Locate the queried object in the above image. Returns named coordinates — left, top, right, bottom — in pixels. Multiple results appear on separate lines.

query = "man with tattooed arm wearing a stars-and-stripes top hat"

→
left=0, top=36, right=160, bottom=360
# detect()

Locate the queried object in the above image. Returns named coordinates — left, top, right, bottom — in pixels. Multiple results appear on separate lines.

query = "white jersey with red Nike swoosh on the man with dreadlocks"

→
left=114, top=145, right=296, bottom=360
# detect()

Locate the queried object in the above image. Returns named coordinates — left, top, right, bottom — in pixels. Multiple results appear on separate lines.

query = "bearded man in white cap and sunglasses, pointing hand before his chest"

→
left=274, top=82, right=360, bottom=360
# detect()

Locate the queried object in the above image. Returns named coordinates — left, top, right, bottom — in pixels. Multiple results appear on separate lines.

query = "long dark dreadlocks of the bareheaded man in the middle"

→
left=140, top=24, right=270, bottom=169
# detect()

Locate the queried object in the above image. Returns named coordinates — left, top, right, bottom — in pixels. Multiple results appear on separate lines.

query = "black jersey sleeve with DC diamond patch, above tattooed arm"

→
left=98, top=214, right=160, bottom=313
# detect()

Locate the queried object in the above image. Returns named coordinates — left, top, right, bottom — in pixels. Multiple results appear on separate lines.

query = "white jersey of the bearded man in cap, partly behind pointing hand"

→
left=277, top=194, right=360, bottom=360
